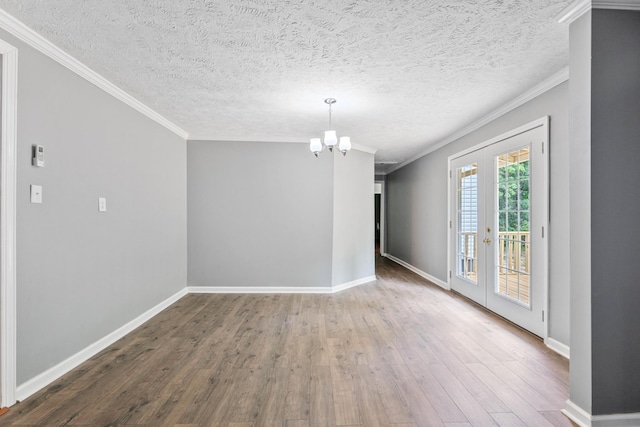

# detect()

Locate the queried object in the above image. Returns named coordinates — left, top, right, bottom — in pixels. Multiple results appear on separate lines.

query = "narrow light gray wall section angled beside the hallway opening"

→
left=332, top=150, right=375, bottom=286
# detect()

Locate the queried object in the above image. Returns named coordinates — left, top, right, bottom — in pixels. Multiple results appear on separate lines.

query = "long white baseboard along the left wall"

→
left=16, top=288, right=187, bottom=401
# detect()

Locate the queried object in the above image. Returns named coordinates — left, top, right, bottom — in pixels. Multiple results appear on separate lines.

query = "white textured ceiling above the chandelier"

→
left=0, top=0, right=569, bottom=171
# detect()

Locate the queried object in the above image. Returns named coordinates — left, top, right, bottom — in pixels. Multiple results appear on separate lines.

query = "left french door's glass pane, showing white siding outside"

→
left=456, top=163, right=478, bottom=284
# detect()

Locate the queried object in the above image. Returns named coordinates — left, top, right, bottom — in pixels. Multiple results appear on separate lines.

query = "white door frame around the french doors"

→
left=447, top=116, right=549, bottom=344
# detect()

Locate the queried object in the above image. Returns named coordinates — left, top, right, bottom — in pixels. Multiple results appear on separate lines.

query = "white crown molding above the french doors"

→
left=385, top=67, right=569, bottom=175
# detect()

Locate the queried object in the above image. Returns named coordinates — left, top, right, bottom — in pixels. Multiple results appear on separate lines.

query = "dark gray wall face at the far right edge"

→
left=592, top=10, right=640, bottom=415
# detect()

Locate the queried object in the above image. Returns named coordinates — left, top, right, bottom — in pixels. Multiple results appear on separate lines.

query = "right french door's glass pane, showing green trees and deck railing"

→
left=495, top=147, right=531, bottom=306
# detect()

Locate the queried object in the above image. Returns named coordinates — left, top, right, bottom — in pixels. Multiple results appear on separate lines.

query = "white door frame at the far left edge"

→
left=0, top=40, right=18, bottom=407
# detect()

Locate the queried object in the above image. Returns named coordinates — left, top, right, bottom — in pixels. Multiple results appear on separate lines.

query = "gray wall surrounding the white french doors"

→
left=386, top=82, right=570, bottom=345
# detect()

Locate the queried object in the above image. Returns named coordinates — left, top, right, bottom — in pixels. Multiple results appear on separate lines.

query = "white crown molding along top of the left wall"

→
left=0, top=9, right=189, bottom=140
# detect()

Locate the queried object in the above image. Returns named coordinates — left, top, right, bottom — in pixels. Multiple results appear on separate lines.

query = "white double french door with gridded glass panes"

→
left=449, top=118, right=548, bottom=338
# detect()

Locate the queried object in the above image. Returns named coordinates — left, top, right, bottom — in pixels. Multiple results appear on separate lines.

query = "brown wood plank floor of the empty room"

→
left=0, top=257, right=573, bottom=427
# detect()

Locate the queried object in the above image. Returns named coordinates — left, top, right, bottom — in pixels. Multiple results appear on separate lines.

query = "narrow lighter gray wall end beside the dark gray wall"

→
left=568, top=12, right=591, bottom=412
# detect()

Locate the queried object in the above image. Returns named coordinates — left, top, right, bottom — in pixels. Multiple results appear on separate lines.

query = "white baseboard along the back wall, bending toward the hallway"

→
left=187, top=276, right=377, bottom=294
